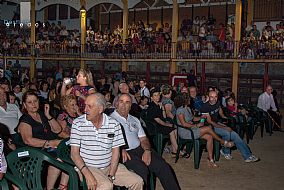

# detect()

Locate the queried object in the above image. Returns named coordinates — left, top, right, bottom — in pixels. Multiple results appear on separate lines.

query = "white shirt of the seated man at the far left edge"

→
left=0, top=103, right=22, bottom=134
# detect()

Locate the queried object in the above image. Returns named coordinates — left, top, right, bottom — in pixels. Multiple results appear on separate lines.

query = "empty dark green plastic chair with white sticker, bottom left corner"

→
left=5, top=147, right=79, bottom=190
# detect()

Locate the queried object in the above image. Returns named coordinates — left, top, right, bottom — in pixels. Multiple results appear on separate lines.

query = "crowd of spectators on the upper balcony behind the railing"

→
left=0, top=16, right=284, bottom=59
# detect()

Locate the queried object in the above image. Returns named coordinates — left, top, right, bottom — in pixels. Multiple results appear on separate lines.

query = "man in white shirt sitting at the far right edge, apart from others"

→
left=257, top=85, right=281, bottom=130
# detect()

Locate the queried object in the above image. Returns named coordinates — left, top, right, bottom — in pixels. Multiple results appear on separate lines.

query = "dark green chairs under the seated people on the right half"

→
left=140, top=105, right=272, bottom=169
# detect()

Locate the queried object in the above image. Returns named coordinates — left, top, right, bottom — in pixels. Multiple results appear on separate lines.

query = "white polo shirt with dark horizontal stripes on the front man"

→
left=70, top=114, right=125, bottom=169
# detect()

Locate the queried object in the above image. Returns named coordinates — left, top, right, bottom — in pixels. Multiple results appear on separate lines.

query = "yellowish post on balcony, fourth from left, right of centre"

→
left=170, top=0, right=179, bottom=74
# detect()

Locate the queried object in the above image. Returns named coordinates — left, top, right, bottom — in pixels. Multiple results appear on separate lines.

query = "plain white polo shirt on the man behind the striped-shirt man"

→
left=110, top=111, right=146, bottom=150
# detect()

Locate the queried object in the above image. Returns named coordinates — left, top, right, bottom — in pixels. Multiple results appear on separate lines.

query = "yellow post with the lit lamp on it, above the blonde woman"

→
left=80, top=0, right=87, bottom=69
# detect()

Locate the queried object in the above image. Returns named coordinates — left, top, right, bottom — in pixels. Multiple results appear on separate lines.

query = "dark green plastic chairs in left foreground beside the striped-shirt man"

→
left=0, top=138, right=126, bottom=190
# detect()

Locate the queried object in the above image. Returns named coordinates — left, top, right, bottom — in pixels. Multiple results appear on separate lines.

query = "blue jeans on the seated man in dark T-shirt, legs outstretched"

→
left=214, top=127, right=251, bottom=160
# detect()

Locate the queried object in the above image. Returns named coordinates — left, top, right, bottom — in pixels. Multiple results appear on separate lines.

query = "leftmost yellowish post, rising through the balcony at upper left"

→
left=30, top=0, right=36, bottom=80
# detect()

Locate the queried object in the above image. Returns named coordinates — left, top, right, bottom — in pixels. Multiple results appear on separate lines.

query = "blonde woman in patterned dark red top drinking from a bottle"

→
left=61, top=69, right=96, bottom=112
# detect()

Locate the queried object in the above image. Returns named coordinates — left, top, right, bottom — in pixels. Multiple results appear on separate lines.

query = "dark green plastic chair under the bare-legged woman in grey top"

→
left=174, top=118, right=220, bottom=169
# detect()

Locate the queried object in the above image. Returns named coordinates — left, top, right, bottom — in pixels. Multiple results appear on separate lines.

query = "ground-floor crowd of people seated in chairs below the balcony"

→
left=0, top=65, right=281, bottom=190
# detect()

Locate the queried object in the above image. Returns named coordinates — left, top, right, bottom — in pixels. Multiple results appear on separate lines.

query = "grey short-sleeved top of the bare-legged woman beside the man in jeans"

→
left=177, top=106, right=200, bottom=139
